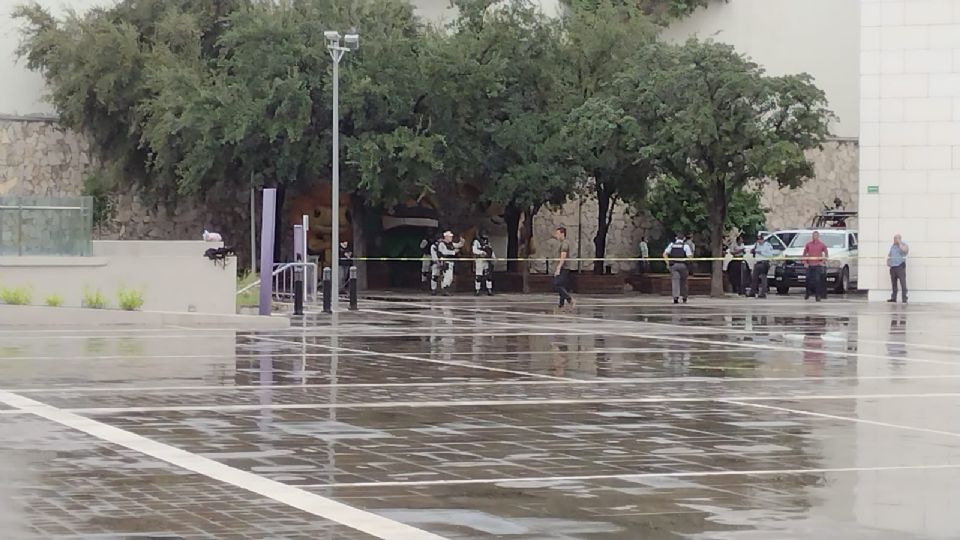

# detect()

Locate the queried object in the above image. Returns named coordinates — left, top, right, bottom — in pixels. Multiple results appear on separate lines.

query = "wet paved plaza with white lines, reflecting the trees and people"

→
left=0, top=296, right=960, bottom=540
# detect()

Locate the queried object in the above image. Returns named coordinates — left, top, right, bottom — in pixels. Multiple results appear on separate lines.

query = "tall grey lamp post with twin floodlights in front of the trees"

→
left=323, top=30, right=360, bottom=312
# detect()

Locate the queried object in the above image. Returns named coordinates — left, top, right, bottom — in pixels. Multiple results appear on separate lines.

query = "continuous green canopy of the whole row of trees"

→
left=16, top=0, right=831, bottom=287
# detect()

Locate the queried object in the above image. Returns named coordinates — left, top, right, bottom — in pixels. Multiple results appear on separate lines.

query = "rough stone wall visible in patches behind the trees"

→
left=0, top=117, right=859, bottom=271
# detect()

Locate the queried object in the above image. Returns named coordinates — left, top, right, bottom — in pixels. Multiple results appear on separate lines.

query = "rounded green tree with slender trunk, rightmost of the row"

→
left=621, top=40, right=833, bottom=295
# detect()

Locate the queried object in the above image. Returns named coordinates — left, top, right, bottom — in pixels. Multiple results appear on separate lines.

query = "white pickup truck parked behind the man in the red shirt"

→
left=773, top=229, right=859, bottom=294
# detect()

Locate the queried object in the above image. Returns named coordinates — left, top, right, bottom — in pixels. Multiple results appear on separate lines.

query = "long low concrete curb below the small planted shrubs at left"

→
left=0, top=305, right=290, bottom=330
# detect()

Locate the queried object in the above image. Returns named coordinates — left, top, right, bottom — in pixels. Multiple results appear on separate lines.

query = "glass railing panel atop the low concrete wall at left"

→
left=0, top=196, right=93, bottom=257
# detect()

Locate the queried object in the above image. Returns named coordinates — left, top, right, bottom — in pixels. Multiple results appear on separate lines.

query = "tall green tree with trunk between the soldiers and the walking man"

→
left=424, top=0, right=574, bottom=269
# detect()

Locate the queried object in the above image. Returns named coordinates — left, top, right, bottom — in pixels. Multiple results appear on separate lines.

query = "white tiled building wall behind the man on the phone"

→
left=860, top=0, right=960, bottom=301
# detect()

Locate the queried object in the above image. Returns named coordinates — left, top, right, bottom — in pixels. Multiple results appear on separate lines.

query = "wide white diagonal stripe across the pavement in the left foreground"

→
left=0, top=391, right=444, bottom=540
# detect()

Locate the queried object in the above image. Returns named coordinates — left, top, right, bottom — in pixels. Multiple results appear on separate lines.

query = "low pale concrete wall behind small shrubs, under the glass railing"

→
left=0, top=241, right=237, bottom=314
